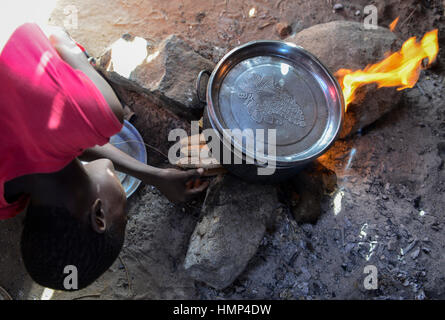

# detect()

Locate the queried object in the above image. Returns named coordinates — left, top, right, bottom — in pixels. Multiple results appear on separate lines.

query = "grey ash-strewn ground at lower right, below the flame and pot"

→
left=197, top=71, right=445, bottom=300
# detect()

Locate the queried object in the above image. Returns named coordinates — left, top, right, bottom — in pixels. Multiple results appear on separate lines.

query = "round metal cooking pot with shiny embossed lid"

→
left=197, top=41, right=345, bottom=183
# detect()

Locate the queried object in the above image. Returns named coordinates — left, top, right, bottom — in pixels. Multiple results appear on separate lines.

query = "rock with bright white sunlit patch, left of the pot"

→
left=98, top=34, right=214, bottom=119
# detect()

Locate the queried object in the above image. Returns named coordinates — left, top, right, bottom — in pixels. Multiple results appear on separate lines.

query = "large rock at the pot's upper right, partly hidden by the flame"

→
left=287, top=21, right=401, bottom=137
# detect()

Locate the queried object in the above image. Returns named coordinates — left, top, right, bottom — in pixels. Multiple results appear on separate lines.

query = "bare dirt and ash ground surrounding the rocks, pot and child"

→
left=0, top=0, right=445, bottom=299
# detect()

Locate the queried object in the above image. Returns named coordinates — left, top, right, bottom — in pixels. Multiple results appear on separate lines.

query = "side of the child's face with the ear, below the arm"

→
left=85, top=159, right=127, bottom=231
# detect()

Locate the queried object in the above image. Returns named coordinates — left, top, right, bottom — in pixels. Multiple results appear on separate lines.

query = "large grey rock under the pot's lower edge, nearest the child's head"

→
left=184, top=175, right=278, bottom=289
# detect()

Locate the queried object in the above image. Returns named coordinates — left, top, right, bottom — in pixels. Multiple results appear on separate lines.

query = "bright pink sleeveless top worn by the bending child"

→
left=0, top=24, right=122, bottom=219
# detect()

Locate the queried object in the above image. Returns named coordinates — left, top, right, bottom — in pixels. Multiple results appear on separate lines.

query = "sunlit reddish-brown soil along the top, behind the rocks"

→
left=51, top=0, right=443, bottom=62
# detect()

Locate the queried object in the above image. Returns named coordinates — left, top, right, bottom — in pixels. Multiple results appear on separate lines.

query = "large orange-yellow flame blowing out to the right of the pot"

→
left=335, top=29, right=439, bottom=108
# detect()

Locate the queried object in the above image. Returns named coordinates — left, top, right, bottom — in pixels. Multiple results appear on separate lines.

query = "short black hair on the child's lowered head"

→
left=21, top=205, right=125, bottom=291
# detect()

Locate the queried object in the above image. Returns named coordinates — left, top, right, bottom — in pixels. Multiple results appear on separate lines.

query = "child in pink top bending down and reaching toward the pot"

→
left=0, top=23, right=208, bottom=290
